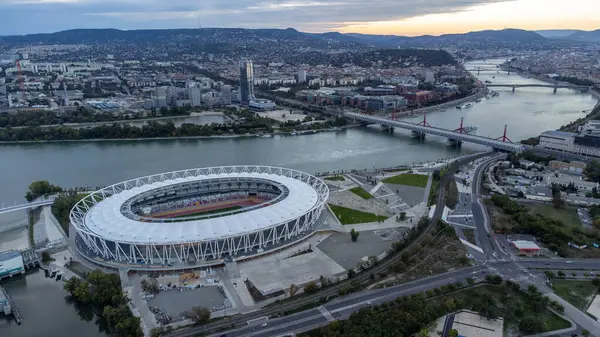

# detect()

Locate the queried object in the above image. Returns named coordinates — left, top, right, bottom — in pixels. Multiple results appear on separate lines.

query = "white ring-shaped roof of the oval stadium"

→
left=85, top=172, right=319, bottom=244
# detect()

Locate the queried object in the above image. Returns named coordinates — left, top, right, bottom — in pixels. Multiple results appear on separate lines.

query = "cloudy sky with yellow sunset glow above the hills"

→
left=0, top=0, right=600, bottom=36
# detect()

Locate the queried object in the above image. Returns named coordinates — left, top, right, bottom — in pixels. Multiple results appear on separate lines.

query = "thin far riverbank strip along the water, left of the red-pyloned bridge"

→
left=0, top=124, right=360, bottom=145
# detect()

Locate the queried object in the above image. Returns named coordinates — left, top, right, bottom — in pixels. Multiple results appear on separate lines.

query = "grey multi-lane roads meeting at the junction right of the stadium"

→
left=169, top=154, right=600, bottom=337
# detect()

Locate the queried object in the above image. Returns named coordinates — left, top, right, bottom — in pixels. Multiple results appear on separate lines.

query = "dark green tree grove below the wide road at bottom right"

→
left=303, top=275, right=564, bottom=337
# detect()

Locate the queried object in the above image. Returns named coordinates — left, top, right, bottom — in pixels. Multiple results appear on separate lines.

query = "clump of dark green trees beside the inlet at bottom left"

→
left=64, top=270, right=144, bottom=337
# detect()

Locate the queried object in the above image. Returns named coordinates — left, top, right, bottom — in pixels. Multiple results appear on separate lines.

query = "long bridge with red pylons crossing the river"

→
left=344, top=112, right=525, bottom=152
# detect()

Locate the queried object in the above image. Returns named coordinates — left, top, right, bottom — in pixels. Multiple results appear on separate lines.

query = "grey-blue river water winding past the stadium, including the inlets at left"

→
left=0, top=60, right=596, bottom=337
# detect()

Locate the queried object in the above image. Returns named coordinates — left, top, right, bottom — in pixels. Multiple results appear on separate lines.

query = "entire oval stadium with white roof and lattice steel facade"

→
left=69, top=166, right=329, bottom=267
